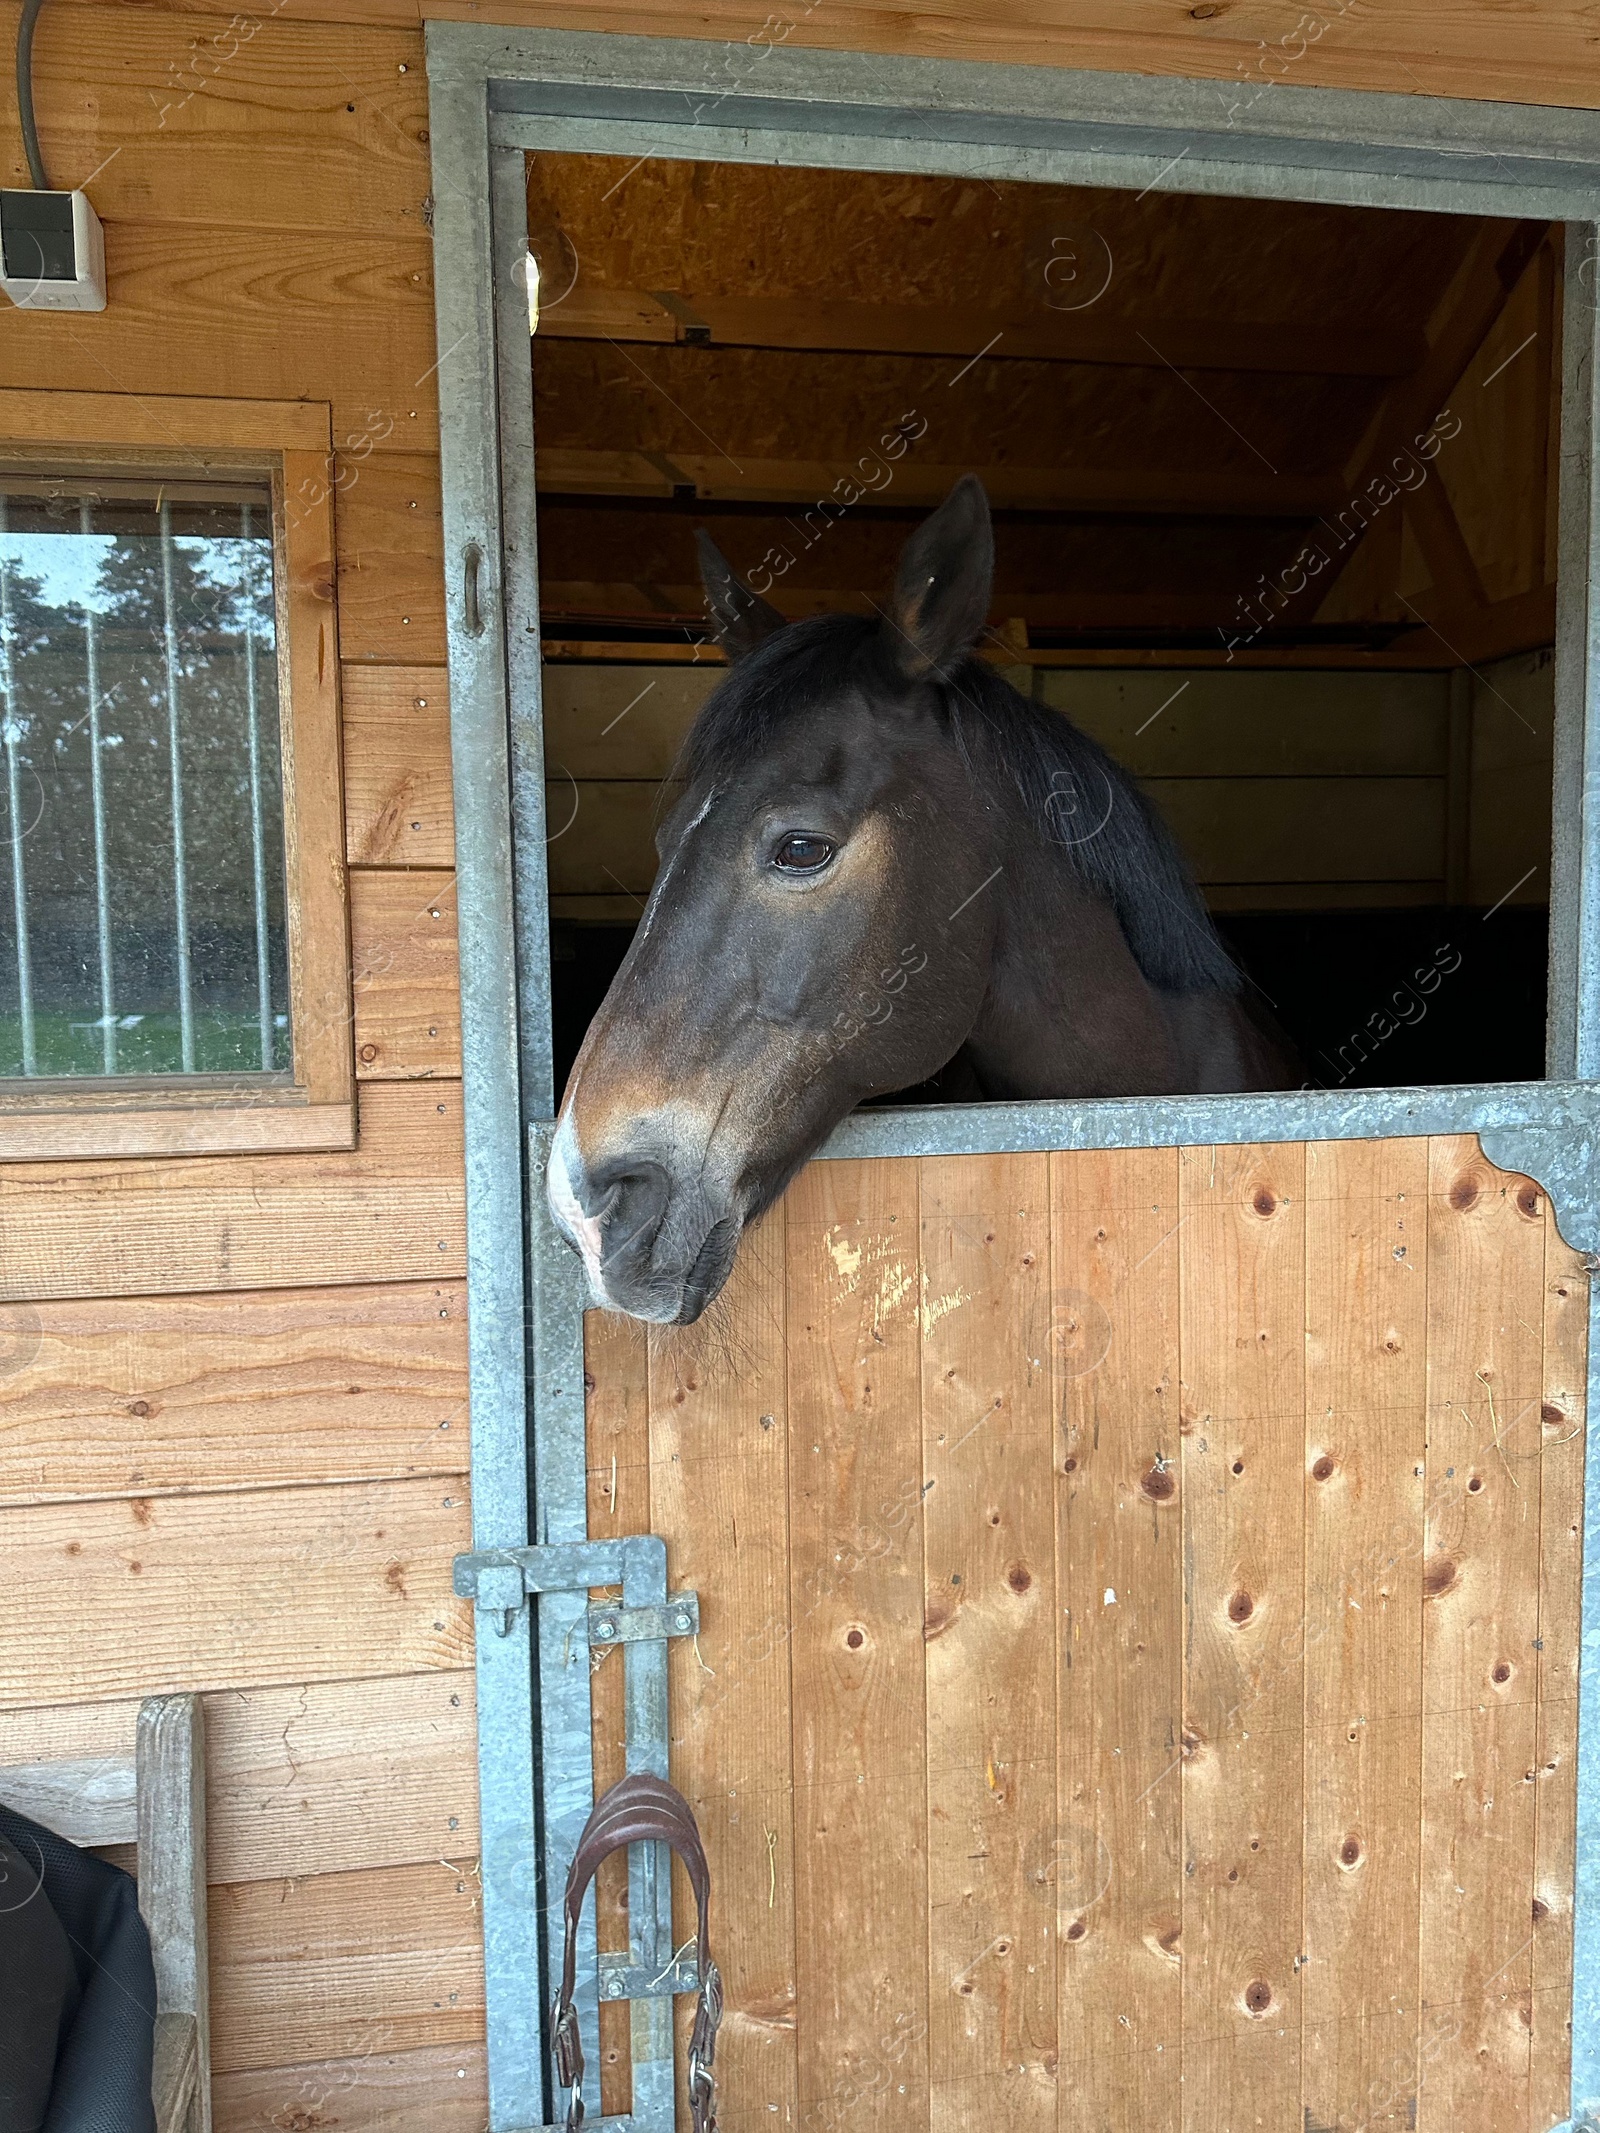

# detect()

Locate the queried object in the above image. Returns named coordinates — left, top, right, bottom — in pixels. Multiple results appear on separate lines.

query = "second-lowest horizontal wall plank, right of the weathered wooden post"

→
left=209, top=1856, right=484, bottom=2073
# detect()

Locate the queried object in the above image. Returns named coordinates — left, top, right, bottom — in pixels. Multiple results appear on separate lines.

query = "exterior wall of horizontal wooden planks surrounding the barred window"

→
left=0, top=4, right=484, bottom=2133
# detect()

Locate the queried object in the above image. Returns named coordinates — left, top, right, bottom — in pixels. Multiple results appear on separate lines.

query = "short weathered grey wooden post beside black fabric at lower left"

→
left=137, top=1696, right=211, bottom=2133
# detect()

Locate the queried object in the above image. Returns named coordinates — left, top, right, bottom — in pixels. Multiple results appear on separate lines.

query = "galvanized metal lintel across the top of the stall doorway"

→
left=429, top=23, right=1600, bottom=220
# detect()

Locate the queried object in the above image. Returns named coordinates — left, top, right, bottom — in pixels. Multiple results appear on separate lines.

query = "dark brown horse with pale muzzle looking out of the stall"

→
left=546, top=476, right=1299, bottom=1325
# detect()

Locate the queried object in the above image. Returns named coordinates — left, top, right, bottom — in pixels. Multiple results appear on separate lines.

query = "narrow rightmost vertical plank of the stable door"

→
left=1519, top=1214, right=1589, bottom=2133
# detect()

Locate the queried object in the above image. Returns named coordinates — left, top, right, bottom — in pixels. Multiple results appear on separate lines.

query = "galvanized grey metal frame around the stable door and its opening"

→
left=427, top=29, right=1600, bottom=2133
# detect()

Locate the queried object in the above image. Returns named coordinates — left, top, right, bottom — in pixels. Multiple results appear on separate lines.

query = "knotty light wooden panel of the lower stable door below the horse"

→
left=589, top=1139, right=1587, bottom=2133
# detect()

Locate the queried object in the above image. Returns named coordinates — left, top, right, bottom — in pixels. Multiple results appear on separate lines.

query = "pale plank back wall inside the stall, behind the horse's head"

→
left=544, top=653, right=1555, bottom=924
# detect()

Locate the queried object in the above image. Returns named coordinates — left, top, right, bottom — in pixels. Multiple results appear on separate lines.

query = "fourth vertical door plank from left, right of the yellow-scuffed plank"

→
left=917, top=1156, right=1060, bottom=2129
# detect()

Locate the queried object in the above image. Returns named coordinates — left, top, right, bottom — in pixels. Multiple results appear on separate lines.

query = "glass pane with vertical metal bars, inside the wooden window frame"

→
left=0, top=476, right=292, bottom=1077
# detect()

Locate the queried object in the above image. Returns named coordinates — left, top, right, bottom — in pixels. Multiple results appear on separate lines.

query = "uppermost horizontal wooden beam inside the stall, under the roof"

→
left=538, top=284, right=1425, bottom=378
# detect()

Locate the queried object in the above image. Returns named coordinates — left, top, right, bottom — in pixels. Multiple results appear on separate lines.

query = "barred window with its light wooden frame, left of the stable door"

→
left=0, top=392, right=352, bottom=1156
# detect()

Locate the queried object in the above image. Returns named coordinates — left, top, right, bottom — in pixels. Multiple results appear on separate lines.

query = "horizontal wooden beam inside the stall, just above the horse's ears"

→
left=535, top=446, right=1342, bottom=518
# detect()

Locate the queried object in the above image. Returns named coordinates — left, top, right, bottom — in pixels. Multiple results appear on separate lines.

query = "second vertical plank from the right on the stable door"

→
left=1417, top=1137, right=1545, bottom=2133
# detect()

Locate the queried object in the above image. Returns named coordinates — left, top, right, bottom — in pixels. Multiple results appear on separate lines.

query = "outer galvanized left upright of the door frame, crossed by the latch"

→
left=429, top=66, right=546, bottom=2133
